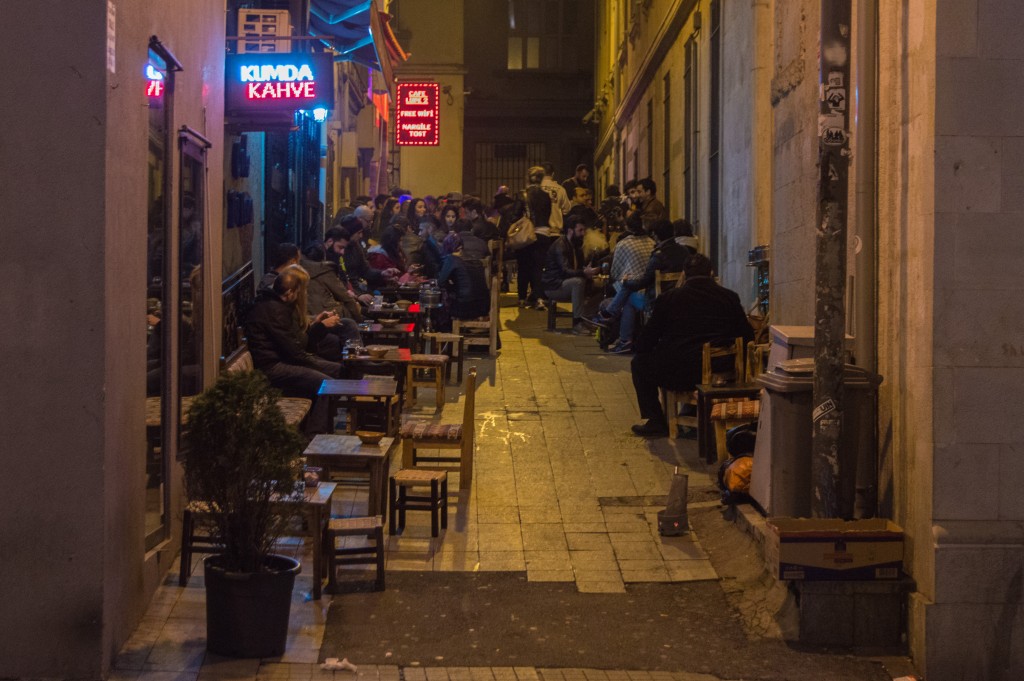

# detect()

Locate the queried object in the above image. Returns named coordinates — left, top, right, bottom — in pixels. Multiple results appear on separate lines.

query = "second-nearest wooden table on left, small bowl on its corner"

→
left=302, top=434, right=398, bottom=518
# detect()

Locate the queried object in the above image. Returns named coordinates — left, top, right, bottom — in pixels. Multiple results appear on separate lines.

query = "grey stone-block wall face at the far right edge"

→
left=923, top=0, right=1024, bottom=681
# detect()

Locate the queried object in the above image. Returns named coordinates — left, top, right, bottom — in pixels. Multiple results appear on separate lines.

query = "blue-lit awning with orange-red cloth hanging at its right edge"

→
left=309, top=0, right=409, bottom=99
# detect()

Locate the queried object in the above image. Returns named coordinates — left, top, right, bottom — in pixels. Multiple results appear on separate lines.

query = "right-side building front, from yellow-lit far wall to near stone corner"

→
left=591, top=0, right=1024, bottom=679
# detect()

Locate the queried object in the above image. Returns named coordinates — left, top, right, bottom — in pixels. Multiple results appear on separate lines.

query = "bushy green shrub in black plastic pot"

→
left=182, top=372, right=302, bottom=657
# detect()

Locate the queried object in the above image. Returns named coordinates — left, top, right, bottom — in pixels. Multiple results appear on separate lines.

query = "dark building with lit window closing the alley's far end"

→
left=463, top=0, right=602, bottom=200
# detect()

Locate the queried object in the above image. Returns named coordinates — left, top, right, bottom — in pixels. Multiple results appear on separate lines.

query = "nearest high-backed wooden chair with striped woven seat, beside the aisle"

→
left=399, top=367, right=476, bottom=490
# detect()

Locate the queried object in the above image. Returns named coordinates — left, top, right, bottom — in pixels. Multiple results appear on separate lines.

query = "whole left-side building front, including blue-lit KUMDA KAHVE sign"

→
left=0, top=0, right=398, bottom=678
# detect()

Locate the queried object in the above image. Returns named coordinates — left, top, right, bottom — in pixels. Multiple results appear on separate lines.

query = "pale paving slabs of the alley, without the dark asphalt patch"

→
left=111, top=297, right=901, bottom=681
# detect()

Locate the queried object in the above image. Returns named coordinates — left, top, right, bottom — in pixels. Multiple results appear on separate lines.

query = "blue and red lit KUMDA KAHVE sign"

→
left=224, top=53, right=334, bottom=116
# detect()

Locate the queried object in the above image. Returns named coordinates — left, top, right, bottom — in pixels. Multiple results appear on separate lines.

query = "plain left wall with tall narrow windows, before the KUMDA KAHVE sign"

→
left=0, top=0, right=224, bottom=678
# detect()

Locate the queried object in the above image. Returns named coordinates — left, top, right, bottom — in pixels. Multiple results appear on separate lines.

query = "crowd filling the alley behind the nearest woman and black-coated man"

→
left=248, top=163, right=712, bottom=364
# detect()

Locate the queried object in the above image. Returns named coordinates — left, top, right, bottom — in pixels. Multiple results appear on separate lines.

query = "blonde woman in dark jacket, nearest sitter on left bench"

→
left=244, top=265, right=350, bottom=435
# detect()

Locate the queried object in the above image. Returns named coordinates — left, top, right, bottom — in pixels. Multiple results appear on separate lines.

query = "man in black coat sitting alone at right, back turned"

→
left=631, top=255, right=754, bottom=437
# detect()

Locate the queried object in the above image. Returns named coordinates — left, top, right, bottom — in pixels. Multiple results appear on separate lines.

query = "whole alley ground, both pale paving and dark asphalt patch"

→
left=111, top=296, right=907, bottom=681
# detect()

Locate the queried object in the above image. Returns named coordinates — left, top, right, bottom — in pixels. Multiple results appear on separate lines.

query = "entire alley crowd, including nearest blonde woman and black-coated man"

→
left=239, top=164, right=752, bottom=446
